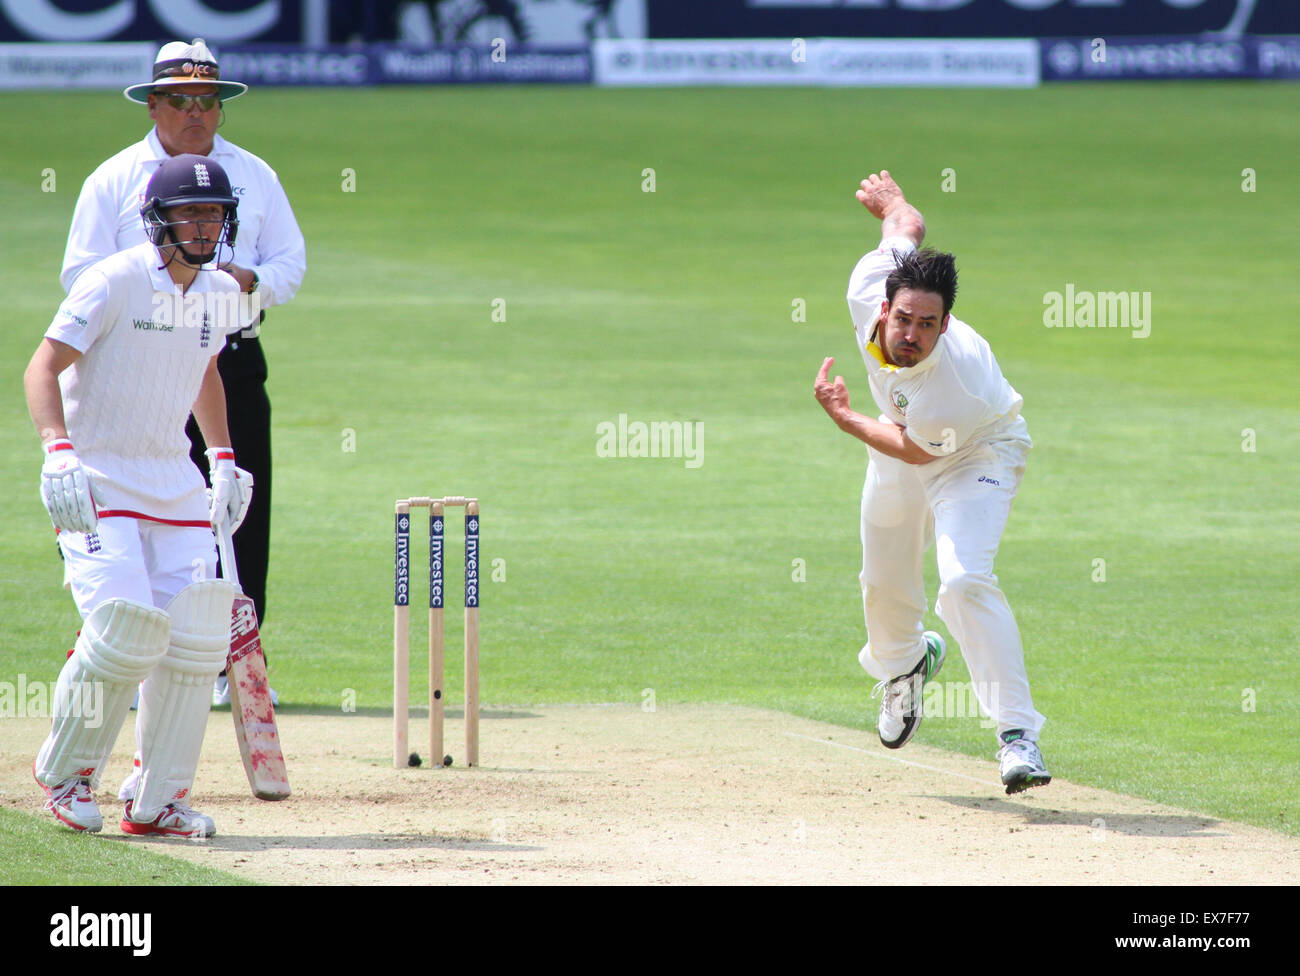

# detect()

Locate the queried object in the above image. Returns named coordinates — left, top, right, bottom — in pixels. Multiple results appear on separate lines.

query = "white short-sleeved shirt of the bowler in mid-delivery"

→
left=848, top=238, right=1030, bottom=462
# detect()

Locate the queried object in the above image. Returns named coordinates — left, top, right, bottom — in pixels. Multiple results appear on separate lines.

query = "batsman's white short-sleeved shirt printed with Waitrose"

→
left=46, top=244, right=241, bottom=525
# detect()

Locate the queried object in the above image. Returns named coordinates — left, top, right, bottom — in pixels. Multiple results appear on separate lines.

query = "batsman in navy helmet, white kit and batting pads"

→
left=23, top=153, right=252, bottom=837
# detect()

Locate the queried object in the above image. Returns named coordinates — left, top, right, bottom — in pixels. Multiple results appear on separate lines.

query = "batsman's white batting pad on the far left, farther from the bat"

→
left=35, top=598, right=172, bottom=789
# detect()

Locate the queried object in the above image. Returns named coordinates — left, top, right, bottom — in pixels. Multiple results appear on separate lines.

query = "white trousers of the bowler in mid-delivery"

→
left=858, top=439, right=1045, bottom=739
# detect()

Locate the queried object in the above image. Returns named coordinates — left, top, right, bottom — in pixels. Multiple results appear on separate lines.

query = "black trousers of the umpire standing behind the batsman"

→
left=185, top=338, right=270, bottom=621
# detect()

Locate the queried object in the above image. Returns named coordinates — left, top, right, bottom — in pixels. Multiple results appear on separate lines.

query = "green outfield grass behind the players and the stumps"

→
left=0, top=83, right=1300, bottom=877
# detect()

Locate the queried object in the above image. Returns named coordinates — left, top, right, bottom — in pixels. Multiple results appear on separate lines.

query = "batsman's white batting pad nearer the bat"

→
left=131, top=580, right=235, bottom=821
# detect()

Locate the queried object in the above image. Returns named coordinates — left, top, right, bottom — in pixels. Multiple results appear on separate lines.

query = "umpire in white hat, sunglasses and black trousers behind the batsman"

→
left=60, top=38, right=307, bottom=702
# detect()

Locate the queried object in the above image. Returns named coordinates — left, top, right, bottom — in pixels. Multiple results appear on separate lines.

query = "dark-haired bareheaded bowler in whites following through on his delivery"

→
left=814, top=170, right=1052, bottom=794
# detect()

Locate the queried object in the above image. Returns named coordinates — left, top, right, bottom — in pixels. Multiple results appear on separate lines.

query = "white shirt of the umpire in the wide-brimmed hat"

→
left=59, top=129, right=307, bottom=332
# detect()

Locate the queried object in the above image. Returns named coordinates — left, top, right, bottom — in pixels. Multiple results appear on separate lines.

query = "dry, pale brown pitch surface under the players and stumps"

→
left=0, top=706, right=1300, bottom=885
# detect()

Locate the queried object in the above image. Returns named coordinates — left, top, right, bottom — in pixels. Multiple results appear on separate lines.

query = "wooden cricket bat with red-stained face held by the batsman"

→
left=216, top=528, right=289, bottom=799
